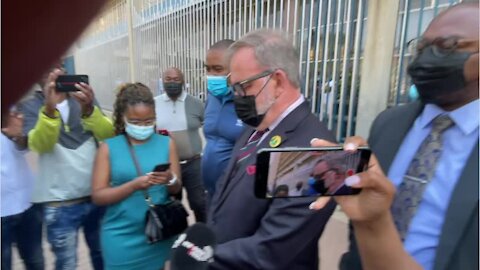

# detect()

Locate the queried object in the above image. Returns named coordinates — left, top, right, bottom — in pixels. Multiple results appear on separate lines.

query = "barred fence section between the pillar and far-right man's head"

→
left=388, top=0, right=462, bottom=106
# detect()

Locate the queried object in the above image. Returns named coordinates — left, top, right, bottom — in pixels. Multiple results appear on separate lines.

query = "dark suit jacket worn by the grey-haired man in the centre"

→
left=208, top=102, right=335, bottom=270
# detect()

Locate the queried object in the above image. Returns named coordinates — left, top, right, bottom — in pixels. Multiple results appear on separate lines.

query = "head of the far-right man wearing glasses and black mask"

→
left=408, top=3, right=480, bottom=111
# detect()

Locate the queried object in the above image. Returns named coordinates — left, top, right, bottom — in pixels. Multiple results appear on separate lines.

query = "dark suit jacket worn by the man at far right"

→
left=340, top=102, right=479, bottom=270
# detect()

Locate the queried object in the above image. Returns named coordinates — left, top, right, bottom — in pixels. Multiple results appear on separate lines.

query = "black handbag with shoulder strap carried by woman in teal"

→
left=125, top=136, right=188, bottom=244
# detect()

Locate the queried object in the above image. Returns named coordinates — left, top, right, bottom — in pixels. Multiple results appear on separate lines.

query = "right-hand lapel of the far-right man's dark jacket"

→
left=434, top=141, right=479, bottom=269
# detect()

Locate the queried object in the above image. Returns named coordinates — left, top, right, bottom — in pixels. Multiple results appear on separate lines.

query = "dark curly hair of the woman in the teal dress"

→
left=113, top=82, right=155, bottom=135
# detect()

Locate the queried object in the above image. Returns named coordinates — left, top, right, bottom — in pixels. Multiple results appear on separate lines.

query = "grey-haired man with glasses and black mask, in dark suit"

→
left=208, top=30, right=335, bottom=270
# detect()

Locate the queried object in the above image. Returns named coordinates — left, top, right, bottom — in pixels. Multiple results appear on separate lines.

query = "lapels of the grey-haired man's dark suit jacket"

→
left=211, top=102, right=310, bottom=213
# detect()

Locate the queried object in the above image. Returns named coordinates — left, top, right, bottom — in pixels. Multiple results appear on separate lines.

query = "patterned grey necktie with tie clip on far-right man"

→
left=392, top=115, right=453, bottom=241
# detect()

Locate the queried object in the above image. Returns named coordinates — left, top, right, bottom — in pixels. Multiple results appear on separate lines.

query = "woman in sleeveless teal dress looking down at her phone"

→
left=92, top=83, right=181, bottom=270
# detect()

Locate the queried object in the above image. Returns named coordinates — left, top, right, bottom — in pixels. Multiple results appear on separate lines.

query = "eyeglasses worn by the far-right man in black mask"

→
left=407, top=36, right=478, bottom=57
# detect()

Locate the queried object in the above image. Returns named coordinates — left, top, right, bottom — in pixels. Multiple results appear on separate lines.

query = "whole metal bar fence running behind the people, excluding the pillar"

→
left=73, top=0, right=468, bottom=141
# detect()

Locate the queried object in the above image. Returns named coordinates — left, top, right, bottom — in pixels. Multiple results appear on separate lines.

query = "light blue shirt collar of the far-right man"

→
left=419, top=99, right=480, bottom=135
